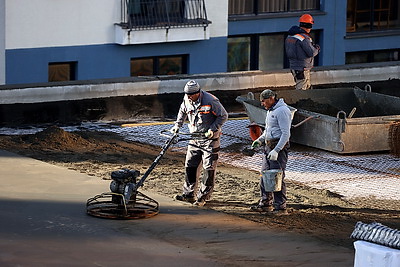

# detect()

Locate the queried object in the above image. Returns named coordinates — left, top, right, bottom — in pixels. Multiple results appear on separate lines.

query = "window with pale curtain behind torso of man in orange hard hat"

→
left=227, top=31, right=319, bottom=72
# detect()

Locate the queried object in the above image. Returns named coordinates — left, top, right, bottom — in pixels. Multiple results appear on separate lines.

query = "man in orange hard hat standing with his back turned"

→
left=285, top=14, right=320, bottom=90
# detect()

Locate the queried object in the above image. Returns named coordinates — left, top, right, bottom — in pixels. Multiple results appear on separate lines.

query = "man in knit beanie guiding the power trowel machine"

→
left=170, top=80, right=228, bottom=206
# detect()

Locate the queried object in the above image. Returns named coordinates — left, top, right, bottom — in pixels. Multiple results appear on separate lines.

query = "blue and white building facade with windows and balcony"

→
left=0, top=0, right=400, bottom=85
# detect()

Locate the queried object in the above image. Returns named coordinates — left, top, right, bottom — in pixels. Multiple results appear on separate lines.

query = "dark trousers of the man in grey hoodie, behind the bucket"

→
left=260, top=146, right=288, bottom=209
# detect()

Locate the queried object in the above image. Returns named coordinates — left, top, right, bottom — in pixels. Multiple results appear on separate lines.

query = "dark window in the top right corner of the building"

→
left=347, top=0, right=400, bottom=32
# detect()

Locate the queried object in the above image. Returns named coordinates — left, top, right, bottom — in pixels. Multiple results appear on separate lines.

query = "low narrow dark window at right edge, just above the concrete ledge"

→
left=346, top=49, right=400, bottom=64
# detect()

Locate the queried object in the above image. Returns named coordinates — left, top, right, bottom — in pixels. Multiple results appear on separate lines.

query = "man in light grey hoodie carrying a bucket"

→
left=250, top=89, right=292, bottom=215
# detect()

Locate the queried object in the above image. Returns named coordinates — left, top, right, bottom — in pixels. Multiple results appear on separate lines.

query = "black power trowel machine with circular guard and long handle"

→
left=86, top=130, right=205, bottom=219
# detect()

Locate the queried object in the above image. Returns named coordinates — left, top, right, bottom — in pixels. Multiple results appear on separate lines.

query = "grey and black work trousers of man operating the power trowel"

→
left=183, top=138, right=220, bottom=200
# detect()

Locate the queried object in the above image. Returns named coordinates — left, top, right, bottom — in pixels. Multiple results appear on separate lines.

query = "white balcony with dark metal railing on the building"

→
left=115, top=0, right=211, bottom=45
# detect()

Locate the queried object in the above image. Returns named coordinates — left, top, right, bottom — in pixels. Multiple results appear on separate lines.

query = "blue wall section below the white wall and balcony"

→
left=6, top=37, right=227, bottom=84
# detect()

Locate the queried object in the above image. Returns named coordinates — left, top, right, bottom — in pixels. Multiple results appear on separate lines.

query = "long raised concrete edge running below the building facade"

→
left=0, top=64, right=400, bottom=104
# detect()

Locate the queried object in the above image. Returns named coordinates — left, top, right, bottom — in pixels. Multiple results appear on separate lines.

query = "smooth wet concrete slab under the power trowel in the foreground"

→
left=0, top=151, right=354, bottom=266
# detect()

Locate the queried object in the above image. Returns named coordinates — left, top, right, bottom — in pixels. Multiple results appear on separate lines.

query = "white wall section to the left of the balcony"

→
left=3, top=0, right=121, bottom=49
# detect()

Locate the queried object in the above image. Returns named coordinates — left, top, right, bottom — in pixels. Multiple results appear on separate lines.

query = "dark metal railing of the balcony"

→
left=120, top=0, right=211, bottom=30
